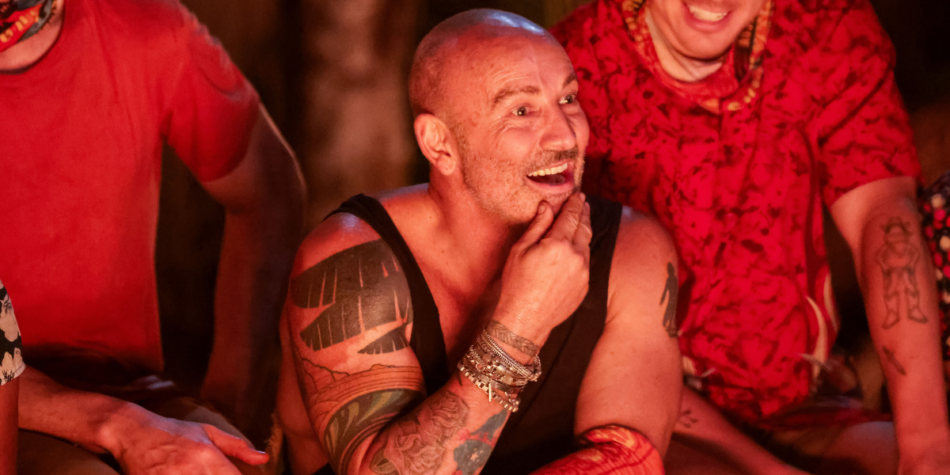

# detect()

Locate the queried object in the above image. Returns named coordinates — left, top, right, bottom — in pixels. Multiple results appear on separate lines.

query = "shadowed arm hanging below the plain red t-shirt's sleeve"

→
left=201, top=107, right=305, bottom=431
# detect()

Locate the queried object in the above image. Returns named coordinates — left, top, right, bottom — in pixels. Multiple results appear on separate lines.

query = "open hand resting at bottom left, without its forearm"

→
left=109, top=410, right=267, bottom=475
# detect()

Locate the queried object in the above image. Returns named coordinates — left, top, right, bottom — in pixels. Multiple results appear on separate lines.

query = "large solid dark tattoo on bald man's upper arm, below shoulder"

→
left=290, top=240, right=412, bottom=354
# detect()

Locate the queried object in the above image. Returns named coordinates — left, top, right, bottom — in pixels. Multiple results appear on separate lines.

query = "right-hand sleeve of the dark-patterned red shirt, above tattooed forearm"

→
left=814, top=0, right=920, bottom=205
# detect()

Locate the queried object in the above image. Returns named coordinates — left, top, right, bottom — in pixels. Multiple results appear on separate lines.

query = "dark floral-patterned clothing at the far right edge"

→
left=919, top=172, right=950, bottom=361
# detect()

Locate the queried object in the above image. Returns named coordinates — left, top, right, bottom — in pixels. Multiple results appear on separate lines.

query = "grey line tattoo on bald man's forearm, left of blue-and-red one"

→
left=370, top=391, right=468, bottom=475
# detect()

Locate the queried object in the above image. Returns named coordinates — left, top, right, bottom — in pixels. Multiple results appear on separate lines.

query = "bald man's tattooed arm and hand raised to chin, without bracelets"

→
left=285, top=195, right=591, bottom=475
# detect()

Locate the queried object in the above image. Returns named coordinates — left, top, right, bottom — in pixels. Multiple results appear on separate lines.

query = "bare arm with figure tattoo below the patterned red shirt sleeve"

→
left=831, top=177, right=950, bottom=474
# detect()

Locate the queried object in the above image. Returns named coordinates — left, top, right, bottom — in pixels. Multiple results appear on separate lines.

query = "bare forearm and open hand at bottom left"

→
left=18, top=367, right=267, bottom=475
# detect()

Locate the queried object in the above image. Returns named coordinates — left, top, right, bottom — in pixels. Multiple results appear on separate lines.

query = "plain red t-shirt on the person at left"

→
left=0, top=0, right=258, bottom=382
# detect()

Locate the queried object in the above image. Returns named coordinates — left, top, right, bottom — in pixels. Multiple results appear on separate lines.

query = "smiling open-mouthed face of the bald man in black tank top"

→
left=446, top=32, right=590, bottom=223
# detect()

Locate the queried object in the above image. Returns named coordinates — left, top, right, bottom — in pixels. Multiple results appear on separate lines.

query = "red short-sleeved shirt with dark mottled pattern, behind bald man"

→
left=553, top=0, right=919, bottom=428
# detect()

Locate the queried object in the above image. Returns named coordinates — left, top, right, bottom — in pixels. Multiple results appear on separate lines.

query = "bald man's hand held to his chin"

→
left=495, top=193, right=592, bottom=342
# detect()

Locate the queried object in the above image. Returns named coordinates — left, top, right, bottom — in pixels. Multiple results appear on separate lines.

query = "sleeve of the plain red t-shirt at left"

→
left=162, top=5, right=259, bottom=181
